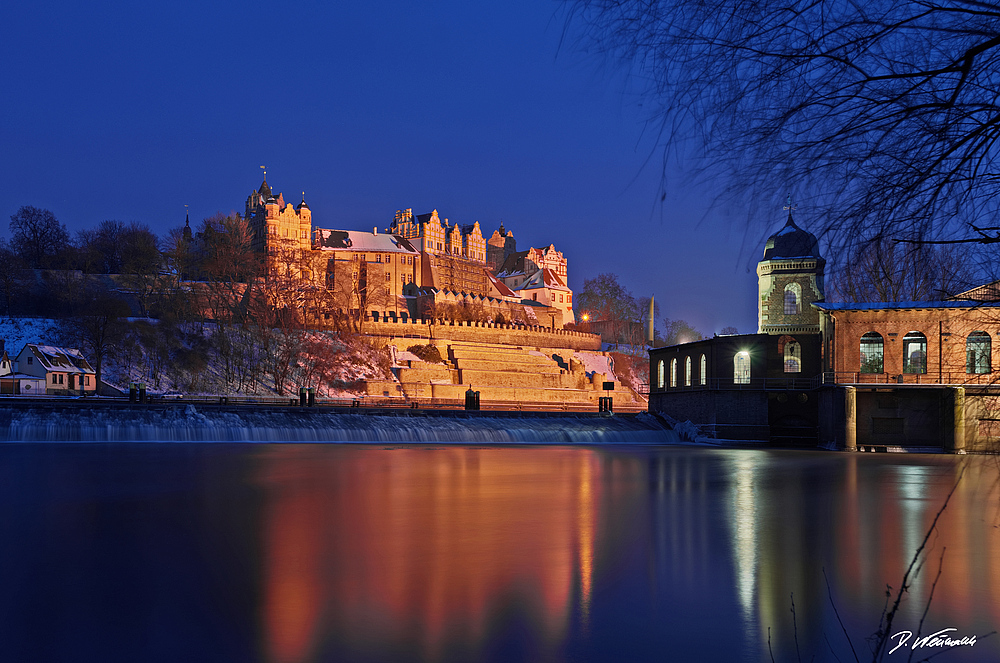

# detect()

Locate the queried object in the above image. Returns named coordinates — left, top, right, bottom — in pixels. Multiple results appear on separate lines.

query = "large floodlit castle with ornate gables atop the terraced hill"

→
left=237, top=174, right=574, bottom=328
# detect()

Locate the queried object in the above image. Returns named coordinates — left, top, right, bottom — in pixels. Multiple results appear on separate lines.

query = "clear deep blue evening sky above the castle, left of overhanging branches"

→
left=0, top=0, right=776, bottom=333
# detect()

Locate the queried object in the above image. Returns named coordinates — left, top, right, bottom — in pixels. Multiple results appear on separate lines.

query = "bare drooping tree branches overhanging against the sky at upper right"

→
left=565, top=0, right=1000, bottom=254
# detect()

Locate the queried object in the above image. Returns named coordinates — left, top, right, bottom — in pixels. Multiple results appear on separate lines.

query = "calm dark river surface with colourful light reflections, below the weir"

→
left=0, top=444, right=1000, bottom=663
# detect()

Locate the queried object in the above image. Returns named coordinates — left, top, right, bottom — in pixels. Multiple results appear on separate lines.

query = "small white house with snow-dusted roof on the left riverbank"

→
left=17, top=343, right=97, bottom=396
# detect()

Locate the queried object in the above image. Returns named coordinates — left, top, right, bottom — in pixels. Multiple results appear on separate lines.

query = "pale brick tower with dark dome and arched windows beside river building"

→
left=757, top=211, right=826, bottom=334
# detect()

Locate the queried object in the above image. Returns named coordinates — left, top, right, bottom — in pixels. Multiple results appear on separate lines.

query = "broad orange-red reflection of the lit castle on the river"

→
left=259, top=447, right=601, bottom=663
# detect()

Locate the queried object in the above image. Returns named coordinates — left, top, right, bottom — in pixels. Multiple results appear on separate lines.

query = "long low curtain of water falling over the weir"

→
left=0, top=405, right=679, bottom=444
